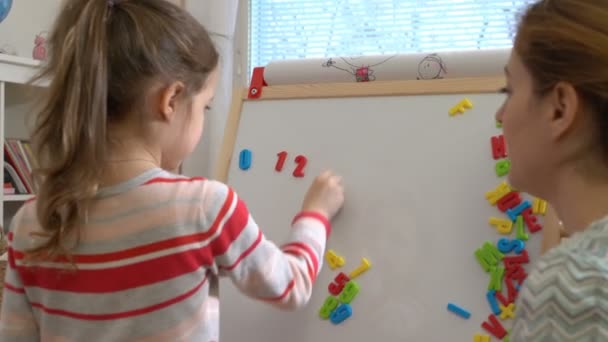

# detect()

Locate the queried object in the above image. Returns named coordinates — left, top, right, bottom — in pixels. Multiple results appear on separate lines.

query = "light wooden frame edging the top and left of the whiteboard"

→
left=215, top=76, right=505, bottom=182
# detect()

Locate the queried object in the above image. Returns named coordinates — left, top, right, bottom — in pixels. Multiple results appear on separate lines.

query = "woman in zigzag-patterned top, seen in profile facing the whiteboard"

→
left=497, top=0, right=608, bottom=342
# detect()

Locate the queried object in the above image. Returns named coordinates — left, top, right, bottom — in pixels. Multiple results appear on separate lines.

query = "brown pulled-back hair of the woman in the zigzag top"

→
left=514, top=0, right=608, bottom=165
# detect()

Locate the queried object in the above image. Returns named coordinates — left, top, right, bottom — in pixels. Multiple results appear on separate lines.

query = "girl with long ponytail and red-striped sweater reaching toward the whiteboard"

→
left=0, top=0, right=343, bottom=342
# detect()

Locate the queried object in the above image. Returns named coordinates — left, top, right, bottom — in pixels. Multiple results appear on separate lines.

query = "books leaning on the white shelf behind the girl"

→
left=4, top=138, right=37, bottom=195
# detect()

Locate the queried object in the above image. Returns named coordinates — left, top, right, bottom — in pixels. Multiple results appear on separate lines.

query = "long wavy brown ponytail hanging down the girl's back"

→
left=32, top=0, right=113, bottom=257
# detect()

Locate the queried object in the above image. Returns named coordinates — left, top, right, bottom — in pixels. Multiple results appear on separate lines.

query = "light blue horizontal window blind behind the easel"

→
left=249, top=0, right=533, bottom=70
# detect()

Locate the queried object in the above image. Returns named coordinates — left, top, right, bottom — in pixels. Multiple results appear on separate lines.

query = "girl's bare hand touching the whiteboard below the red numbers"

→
left=302, top=171, right=344, bottom=220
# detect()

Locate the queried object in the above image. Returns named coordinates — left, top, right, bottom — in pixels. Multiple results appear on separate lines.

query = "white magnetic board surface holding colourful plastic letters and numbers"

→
left=220, top=93, right=540, bottom=342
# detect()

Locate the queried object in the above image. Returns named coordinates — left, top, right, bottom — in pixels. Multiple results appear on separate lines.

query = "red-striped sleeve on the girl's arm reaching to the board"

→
left=203, top=181, right=330, bottom=309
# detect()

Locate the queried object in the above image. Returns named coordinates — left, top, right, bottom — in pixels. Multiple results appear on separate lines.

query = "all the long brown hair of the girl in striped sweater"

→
left=30, top=0, right=219, bottom=258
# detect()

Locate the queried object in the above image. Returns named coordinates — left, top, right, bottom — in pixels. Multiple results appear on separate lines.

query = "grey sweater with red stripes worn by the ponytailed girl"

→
left=0, top=169, right=330, bottom=342
